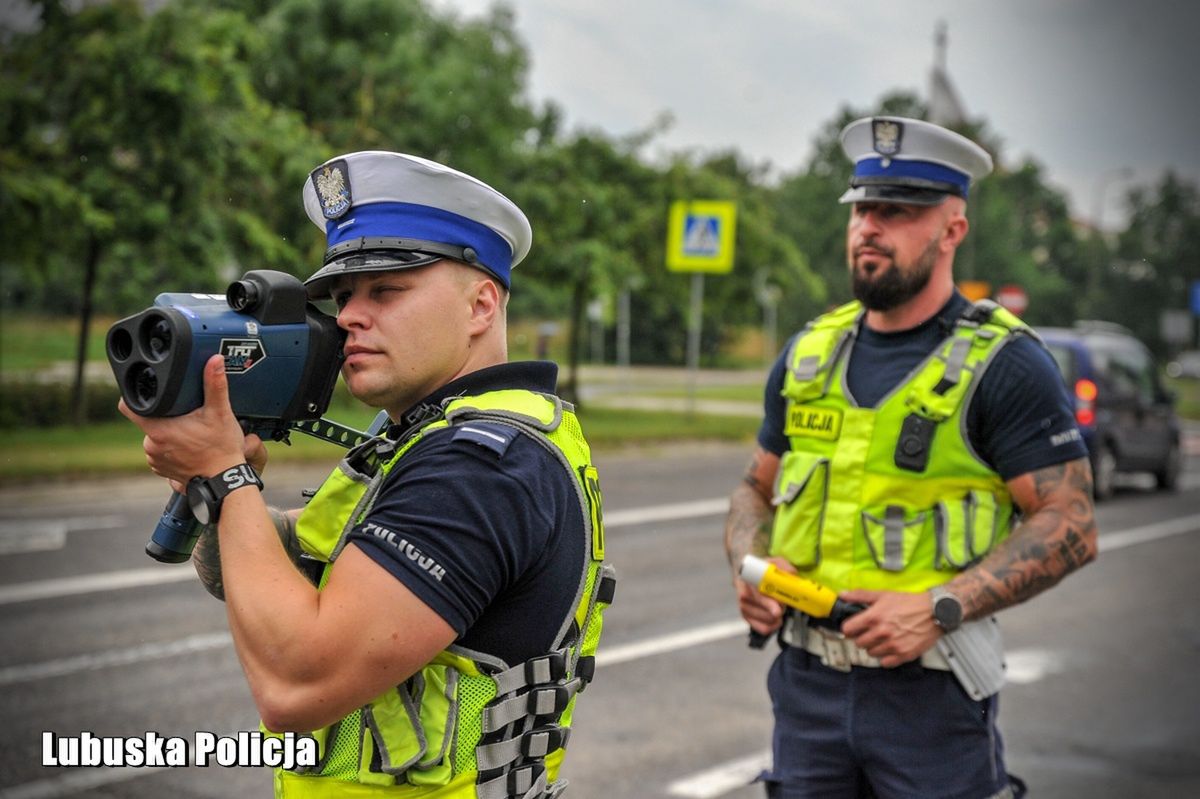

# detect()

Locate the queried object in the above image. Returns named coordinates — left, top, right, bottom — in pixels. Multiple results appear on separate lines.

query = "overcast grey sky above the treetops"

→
left=432, top=0, right=1200, bottom=227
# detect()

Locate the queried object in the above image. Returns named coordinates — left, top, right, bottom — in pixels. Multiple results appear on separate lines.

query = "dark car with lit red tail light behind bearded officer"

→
left=1038, top=322, right=1182, bottom=499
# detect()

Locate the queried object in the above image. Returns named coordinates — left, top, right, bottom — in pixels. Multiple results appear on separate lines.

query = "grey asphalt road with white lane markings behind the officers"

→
left=0, top=446, right=1200, bottom=799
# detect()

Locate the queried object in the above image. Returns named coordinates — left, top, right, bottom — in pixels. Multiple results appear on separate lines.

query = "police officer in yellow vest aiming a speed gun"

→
left=117, top=151, right=616, bottom=799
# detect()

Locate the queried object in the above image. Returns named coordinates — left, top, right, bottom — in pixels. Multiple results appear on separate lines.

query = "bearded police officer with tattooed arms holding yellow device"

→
left=725, top=116, right=1097, bottom=799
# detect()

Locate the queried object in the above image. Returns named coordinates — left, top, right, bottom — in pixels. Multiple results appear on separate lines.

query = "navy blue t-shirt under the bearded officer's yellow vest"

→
left=758, top=292, right=1087, bottom=480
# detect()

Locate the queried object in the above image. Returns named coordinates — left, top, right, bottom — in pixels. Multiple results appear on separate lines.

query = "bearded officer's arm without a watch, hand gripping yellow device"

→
left=725, top=447, right=796, bottom=635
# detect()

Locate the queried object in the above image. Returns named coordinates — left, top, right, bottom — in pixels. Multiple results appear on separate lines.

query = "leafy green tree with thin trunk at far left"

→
left=0, top=0, right=324, bottom=419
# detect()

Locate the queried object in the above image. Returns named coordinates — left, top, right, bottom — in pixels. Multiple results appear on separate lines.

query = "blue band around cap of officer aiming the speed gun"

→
left=325, top=203, right=512, bottom=288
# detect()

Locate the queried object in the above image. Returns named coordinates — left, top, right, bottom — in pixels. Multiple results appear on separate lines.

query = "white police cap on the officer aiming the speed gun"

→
left=304, top=150, right=533, bottom=298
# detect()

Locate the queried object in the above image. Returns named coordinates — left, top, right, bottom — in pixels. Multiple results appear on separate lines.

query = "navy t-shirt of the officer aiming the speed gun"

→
left=349, top=362, right=587, bottom=663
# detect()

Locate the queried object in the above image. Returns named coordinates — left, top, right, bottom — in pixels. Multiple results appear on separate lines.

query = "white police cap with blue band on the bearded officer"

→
left=839, top=116, right=991, bottom=205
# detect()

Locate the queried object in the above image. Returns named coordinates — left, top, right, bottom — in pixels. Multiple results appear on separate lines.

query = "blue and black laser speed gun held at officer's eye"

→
left=106, top=269, right=386, bottom=563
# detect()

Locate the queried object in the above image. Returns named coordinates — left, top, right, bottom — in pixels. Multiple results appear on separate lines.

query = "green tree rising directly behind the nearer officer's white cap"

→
left=208, top=0, right=535, bottom=186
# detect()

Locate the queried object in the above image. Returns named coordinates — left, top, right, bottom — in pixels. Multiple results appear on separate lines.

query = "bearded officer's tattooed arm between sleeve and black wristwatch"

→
left=947, top=461, right=1097, bottom=619
